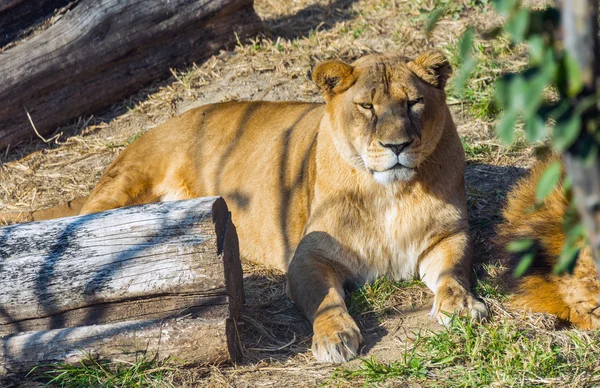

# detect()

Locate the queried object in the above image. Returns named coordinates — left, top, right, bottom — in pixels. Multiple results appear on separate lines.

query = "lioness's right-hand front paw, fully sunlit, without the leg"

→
left=431, top=285, right=488, bottom=326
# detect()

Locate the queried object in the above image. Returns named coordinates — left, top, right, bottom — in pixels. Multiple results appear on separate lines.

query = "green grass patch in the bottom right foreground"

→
left=333, top=318, right=600, bottom=387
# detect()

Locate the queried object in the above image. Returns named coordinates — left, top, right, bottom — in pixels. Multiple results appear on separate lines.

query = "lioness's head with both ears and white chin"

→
left=313, top=51, right=452, bottom=184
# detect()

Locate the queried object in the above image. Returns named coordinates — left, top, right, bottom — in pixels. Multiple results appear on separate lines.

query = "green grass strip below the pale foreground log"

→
left=28, top=356, right=175, bottom=388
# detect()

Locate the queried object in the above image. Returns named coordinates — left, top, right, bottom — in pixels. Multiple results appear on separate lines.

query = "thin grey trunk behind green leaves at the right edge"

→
left=560, top=0, right=600, bottom=273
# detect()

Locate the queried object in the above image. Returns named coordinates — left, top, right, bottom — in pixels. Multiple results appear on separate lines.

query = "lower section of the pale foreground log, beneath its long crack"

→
left=0, top=318, right=230, bottom=378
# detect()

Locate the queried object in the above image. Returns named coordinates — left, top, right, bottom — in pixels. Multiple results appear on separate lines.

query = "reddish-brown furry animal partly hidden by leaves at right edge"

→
left=498, top=159, right=600, bottom=329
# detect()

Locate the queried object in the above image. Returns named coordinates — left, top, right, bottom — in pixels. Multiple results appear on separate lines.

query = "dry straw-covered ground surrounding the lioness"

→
left=0, top=0, right=552, bottom=387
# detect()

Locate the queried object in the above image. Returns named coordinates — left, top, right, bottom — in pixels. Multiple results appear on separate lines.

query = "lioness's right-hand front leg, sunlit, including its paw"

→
left=419, top=232, right=488, bottom=325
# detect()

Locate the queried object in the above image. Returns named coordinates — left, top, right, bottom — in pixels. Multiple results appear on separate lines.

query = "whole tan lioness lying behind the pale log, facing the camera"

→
left=10, top=51, right=487, bottom=362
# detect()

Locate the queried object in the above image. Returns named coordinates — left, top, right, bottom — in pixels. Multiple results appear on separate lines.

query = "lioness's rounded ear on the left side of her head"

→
left=312, top=60, right=356, bottom=101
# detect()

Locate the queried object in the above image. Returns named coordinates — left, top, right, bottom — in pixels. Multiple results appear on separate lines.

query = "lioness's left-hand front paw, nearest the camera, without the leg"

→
left=312, top=311, right=362, bottom=362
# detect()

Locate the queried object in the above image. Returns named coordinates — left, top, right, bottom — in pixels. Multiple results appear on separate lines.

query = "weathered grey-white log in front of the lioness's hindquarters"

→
left=0, top=197, right=244, bottom=375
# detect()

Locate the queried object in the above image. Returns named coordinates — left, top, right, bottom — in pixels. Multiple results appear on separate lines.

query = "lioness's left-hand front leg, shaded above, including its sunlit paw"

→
left=288, top=233, right=362, bottom=362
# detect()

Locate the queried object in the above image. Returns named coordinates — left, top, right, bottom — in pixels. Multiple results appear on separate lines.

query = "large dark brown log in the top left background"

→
left=0, top=0, right=262, bottom=148
